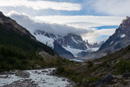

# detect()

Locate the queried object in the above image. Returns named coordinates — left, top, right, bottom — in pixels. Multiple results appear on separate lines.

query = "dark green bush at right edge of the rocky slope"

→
left=116, top=60, right=130, bottom=74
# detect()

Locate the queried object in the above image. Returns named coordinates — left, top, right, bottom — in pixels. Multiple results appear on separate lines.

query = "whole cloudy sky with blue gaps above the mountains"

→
left=0, top=0, right=130, bottom=43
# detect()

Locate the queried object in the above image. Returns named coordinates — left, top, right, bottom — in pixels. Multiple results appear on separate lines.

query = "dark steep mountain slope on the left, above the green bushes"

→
left=0, top=12, right=55, bottom=55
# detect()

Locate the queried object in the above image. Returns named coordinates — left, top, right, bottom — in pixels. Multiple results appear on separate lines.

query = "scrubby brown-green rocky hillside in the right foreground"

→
left=57, top=46, right=130, bottom=87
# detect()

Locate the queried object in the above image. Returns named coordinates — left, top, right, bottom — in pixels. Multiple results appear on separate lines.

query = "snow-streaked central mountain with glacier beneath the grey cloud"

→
left=34, top=30, right=101, bottom=58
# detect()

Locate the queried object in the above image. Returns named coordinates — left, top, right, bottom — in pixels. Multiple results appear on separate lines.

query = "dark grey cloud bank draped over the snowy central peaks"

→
left=7, top=11, right=93, bottom=35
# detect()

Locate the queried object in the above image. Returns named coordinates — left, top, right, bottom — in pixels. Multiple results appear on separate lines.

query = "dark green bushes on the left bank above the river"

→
left=0, top=45, right=44, bottom=71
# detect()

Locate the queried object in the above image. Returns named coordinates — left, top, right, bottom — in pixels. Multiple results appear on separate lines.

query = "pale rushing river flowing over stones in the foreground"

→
left=0, top=68, right=73, bottom=87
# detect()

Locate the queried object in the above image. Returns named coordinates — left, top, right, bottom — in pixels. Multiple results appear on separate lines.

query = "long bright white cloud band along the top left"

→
left=0, top=0, right=81, bottom=11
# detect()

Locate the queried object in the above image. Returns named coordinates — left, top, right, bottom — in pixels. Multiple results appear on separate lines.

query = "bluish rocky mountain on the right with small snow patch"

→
left=88, top=16, right=130, bottom=58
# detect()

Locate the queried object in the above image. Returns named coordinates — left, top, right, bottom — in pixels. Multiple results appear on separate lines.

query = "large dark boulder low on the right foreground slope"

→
left=95, top=74, right=114, bottom=86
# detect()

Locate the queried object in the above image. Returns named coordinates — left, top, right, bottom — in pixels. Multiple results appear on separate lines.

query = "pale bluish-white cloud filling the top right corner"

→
left=87, top=0, right=130, bottom=16
